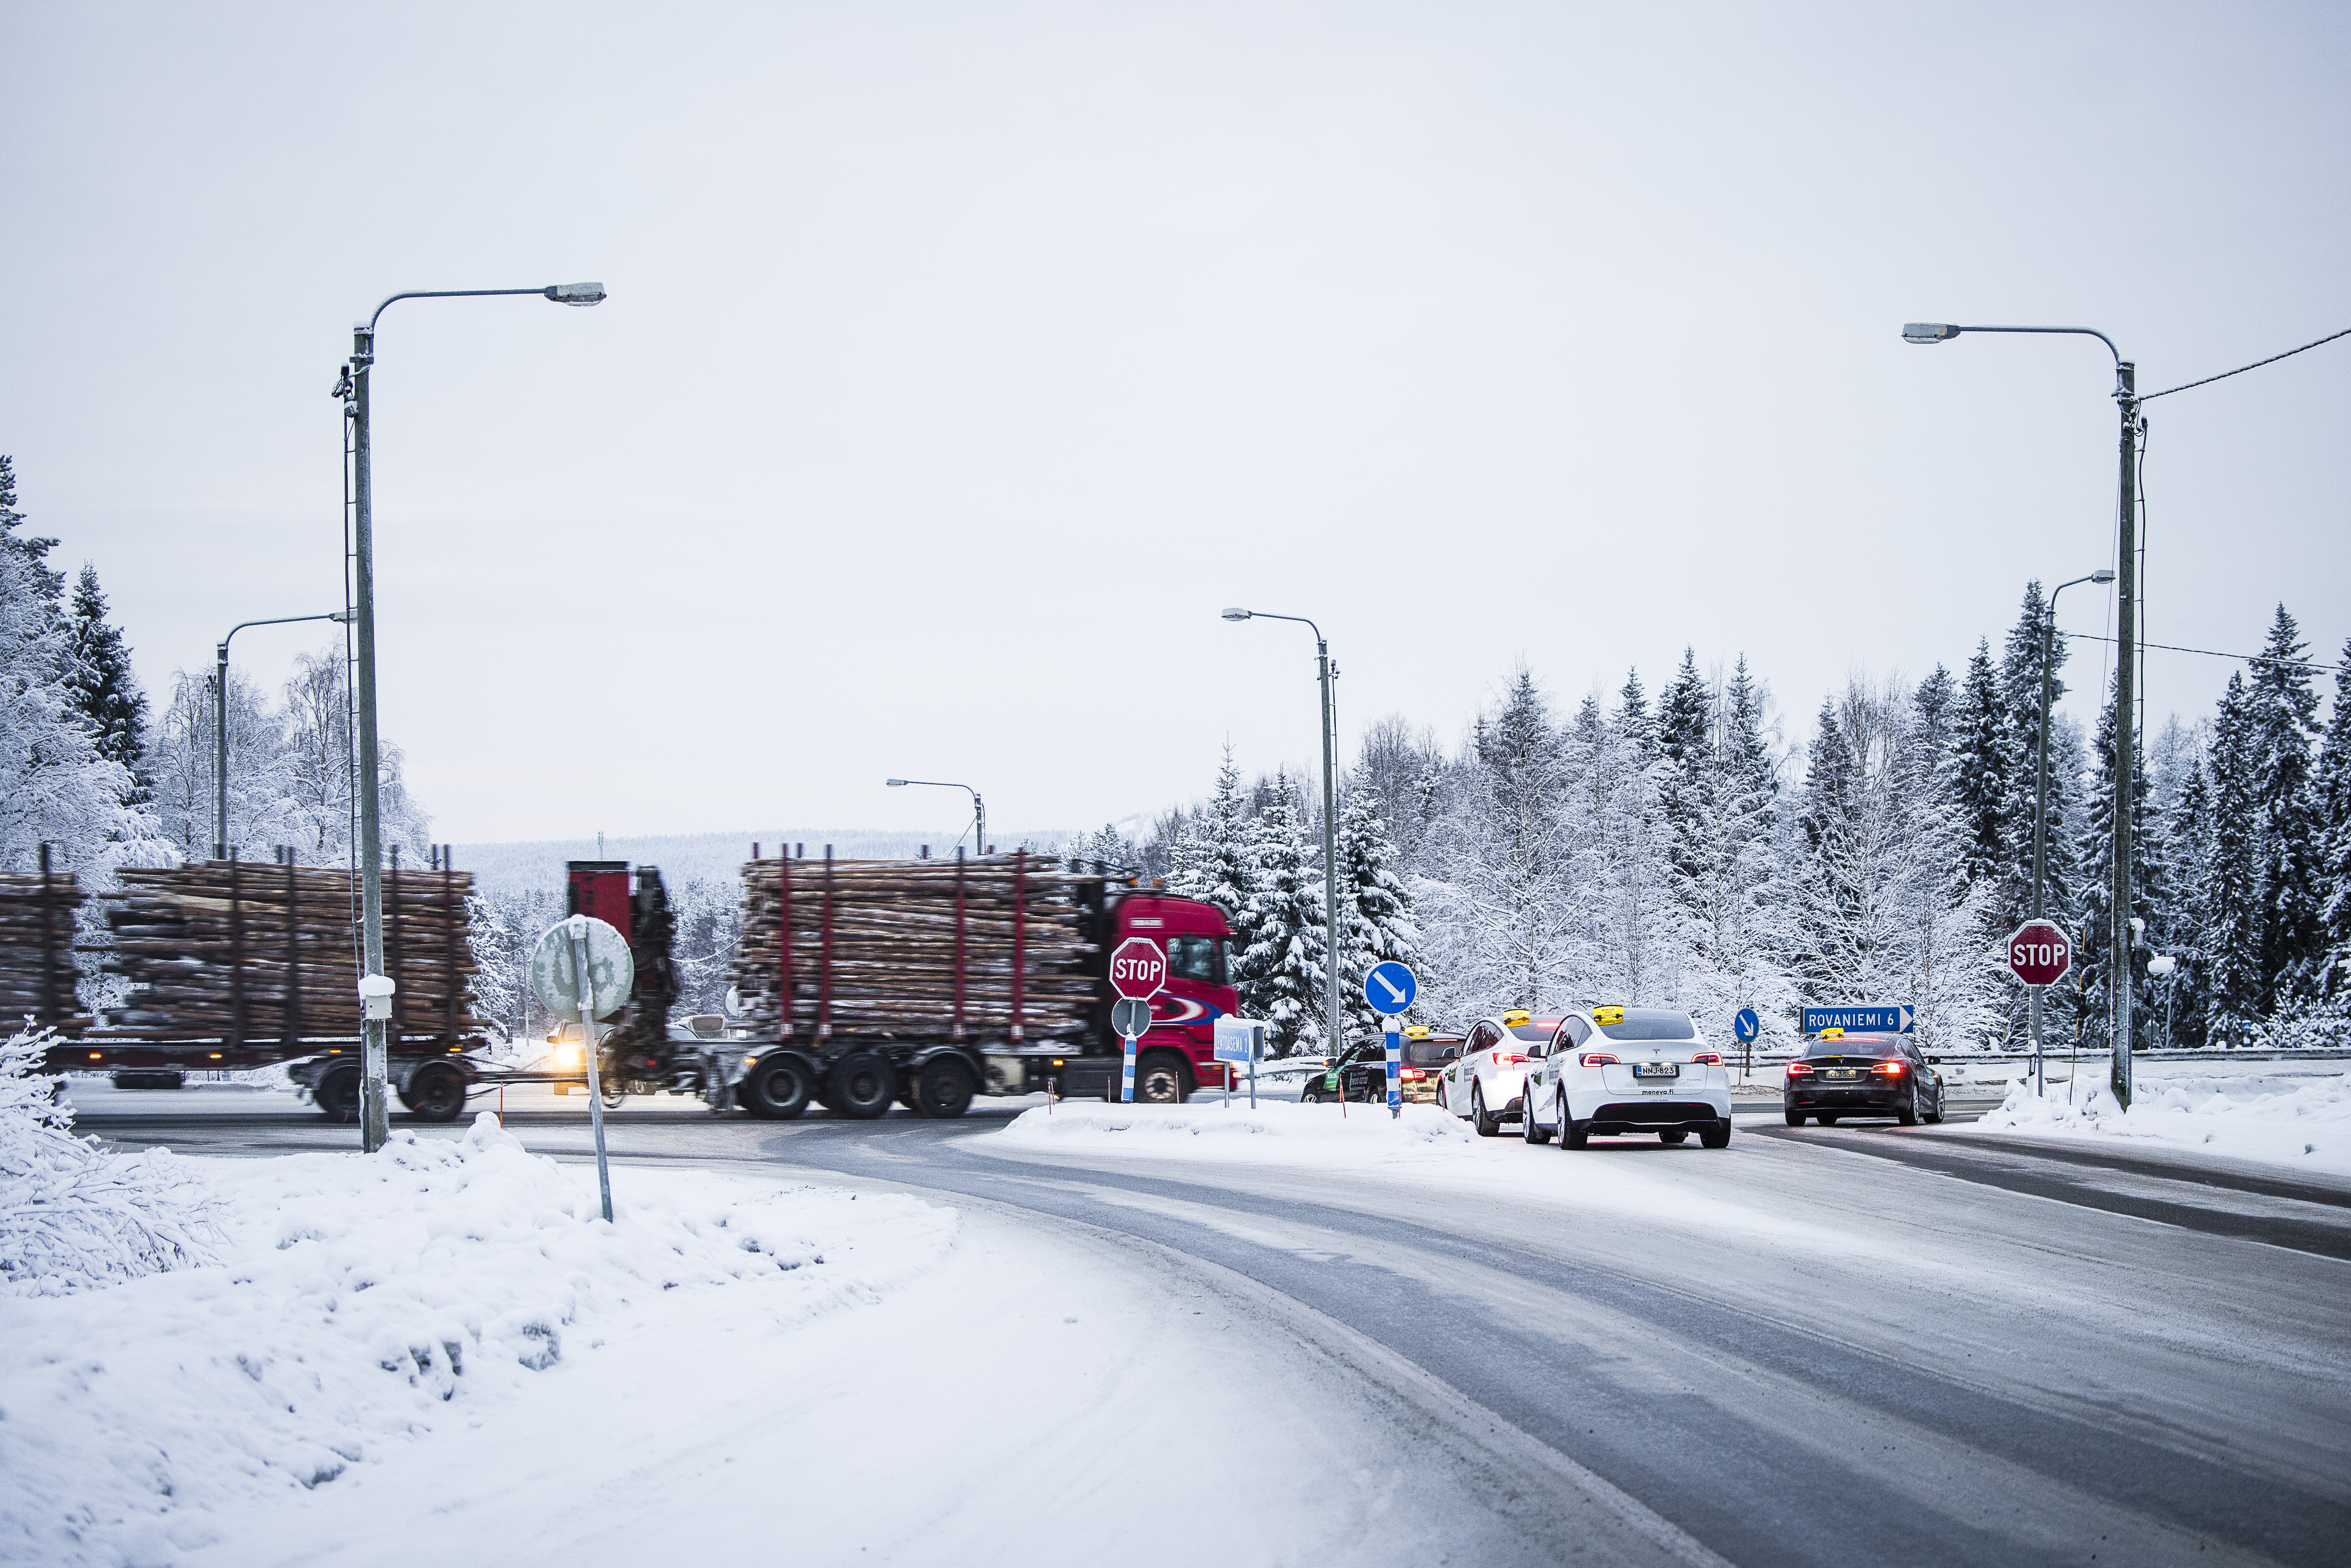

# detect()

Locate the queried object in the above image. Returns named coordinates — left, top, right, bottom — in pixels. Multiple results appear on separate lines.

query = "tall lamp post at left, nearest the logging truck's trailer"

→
left=334, top=282, right=604, bottom=1152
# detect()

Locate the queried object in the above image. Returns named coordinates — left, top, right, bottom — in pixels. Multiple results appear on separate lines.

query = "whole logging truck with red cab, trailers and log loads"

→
left=22, top=846, right=1237, bottom=1121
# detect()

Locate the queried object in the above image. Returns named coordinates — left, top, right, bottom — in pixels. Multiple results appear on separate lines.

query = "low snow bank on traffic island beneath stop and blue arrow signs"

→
left=995, top=1096, right=1479, bottom=1159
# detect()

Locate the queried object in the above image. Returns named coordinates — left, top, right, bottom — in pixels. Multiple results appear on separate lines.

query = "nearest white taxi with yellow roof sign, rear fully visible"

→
left=1521, top=1006, right=1730, bottom=1149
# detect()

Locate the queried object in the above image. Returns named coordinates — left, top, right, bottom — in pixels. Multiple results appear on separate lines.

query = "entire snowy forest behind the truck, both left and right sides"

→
left=0, top=458, right=2351, bottom=1051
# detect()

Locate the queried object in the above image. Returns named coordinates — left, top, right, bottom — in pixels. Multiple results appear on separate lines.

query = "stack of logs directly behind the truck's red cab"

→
left=734, top=853, right=1103, bottom=1046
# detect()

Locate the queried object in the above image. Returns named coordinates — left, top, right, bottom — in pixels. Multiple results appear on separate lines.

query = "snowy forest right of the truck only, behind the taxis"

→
left=1110, top=585, right=2351, bottom=1051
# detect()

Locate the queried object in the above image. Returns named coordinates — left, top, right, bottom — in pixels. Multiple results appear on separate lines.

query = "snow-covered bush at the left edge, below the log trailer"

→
left=0, top=1030, right=216, bottom=1295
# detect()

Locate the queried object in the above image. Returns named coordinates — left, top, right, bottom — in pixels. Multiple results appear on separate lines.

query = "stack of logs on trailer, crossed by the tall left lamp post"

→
left=101, top=861, right=484, bottom=1046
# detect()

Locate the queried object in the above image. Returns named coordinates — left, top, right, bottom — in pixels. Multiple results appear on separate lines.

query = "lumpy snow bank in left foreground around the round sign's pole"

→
left=0, top=1114, right=955, bottom=1563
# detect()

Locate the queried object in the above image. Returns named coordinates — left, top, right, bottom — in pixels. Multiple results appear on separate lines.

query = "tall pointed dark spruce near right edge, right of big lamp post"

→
left=2245, top=604, right=2325, bottom=1016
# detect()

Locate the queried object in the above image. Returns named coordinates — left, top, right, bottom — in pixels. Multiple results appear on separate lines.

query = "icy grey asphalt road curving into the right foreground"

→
left=83, top=1096, right=2351, bottom=1568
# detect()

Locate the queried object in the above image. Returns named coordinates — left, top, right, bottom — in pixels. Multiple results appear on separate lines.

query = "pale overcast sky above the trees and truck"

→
left=0, top=0, right=2351, bottom=842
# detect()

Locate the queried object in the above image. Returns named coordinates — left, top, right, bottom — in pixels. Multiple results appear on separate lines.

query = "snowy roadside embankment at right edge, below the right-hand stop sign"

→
left=1977, top=1072, right=2351, bottom=1176
